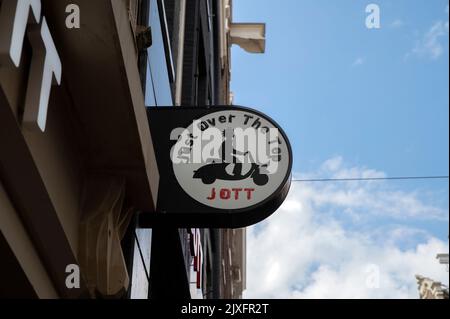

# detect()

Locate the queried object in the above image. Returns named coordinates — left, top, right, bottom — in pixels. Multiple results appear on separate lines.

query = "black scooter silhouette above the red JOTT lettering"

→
left=193, top=154, right=269, bottom=186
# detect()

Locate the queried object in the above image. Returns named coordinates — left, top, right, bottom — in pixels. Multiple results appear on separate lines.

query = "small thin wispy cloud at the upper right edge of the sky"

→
left=406, top=5, right=449, bottom=60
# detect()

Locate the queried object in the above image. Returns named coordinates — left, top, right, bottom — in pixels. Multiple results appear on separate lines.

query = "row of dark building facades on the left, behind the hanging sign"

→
left=0, top=0, right=265, bottom=298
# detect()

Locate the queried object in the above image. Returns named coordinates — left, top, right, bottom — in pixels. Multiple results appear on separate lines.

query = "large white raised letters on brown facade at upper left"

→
left=0, top=0, right=62, bottom=132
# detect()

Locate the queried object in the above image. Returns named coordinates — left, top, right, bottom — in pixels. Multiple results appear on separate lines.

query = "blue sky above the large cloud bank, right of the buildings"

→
left=232, top=0, right=449, bottom=296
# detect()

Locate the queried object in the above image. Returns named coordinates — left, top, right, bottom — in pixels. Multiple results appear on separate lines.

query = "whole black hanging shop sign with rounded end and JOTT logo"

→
left=141, top=106, right=292, bottom=228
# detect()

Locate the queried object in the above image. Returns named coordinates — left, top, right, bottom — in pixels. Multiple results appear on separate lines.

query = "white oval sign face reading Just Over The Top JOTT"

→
left=171, top=110, right=291, bottom=210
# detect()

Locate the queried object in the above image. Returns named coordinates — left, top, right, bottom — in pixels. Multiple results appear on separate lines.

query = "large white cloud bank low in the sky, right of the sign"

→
left=244, top=157, right=448, bottom=298
